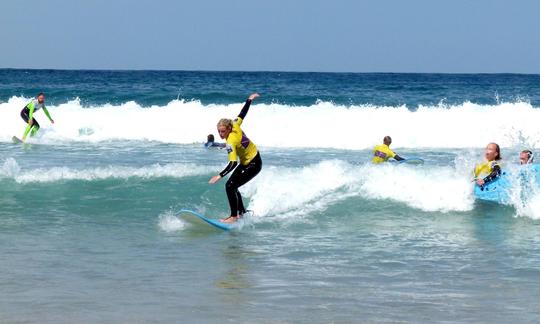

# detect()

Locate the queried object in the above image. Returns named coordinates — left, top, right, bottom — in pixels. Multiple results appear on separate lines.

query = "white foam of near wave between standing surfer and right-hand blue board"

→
left=241, top=160, right=474, bottom=221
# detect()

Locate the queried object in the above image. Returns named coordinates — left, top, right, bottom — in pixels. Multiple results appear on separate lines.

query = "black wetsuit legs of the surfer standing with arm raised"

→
left=225, top=153, right=262, bottom=216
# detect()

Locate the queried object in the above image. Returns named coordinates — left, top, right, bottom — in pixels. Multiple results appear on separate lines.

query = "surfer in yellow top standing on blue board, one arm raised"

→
left=208, top=93, right=262, bottom=223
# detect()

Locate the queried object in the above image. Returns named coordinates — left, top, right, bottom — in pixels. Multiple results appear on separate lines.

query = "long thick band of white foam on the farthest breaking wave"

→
left=0, top=97, right=540, bottom=149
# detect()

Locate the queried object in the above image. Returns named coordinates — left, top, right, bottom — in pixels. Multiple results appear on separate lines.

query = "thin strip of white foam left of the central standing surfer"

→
left=0, top=158, right=215, bottom=183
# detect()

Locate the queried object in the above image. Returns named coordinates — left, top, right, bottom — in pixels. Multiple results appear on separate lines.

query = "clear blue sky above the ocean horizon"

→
left=0, top=0, right=540, bottom=73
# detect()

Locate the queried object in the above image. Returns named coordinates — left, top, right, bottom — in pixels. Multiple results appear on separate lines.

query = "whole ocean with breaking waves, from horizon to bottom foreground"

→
left=0, top=69, right=540, bottom=323
